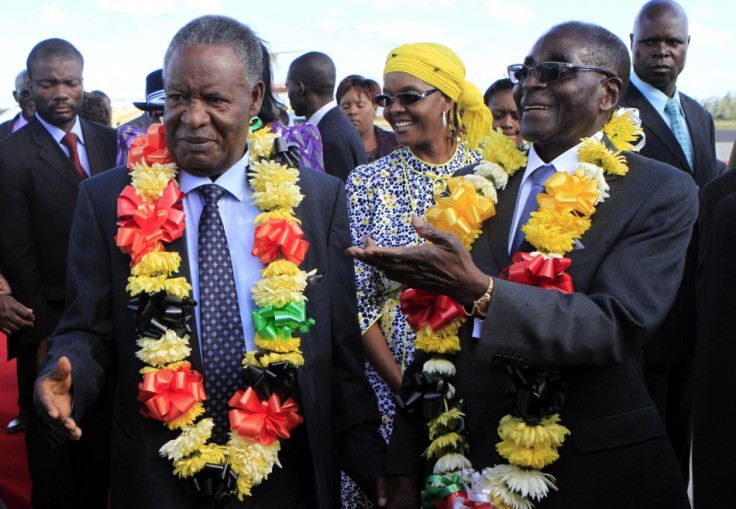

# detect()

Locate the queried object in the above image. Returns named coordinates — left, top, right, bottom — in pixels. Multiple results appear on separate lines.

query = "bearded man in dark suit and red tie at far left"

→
left=0, top=39, right=116, bottom=508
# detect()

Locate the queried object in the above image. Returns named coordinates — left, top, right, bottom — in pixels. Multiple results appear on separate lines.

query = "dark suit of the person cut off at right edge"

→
left=693, top=170, right=736, bottom=508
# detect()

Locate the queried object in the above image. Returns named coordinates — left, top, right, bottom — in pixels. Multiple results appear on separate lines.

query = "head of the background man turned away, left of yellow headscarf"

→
left=286, top=51, right=336, bottom=117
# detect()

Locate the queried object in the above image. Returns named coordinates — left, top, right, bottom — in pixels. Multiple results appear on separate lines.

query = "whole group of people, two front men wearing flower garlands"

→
left=0, top=0, right=736, bottom=509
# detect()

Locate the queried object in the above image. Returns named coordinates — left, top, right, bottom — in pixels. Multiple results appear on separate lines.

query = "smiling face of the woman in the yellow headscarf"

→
left=383, top=72, right=452, bottom=148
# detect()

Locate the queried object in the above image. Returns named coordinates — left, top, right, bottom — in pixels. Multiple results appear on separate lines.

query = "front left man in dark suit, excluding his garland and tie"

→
left=30, top=16, right=385, bottom=509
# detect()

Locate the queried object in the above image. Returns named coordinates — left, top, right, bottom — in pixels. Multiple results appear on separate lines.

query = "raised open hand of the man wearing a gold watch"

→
left=345, top=216, right=488, bottom=306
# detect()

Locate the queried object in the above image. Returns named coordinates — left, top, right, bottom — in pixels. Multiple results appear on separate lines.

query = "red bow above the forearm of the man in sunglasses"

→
left=499, top=252, right=575, bottom=293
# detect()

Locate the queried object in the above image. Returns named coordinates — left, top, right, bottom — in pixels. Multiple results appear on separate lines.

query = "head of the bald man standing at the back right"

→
left=631, top=0, right=690, bottom=97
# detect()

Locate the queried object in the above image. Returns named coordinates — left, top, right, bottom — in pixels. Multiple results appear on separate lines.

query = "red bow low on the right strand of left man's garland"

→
left=229, top=387, right=304, bottom=445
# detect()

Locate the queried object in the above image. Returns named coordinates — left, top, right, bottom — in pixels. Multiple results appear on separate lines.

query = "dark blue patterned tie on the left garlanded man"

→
left=197, top=184, right=245, bottom=444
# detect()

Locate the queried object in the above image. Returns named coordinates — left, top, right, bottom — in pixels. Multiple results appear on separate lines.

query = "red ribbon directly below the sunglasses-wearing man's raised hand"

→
left=401, top=288, right=465, bottom=331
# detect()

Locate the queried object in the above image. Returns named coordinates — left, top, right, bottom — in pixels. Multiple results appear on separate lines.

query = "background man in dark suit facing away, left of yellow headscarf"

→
left=286, top=51, right=368, bottom=182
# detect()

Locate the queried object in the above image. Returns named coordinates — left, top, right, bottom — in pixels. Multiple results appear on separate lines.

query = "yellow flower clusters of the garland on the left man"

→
left=126, top=124, right=307, bottom=500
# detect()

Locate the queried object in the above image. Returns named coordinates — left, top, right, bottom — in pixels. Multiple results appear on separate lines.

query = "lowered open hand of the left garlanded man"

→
left=33, top=357, right=82, bottom=440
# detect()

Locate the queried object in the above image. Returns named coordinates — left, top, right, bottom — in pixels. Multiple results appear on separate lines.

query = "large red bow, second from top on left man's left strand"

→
left=115, top=180, right=185, bottom=267
